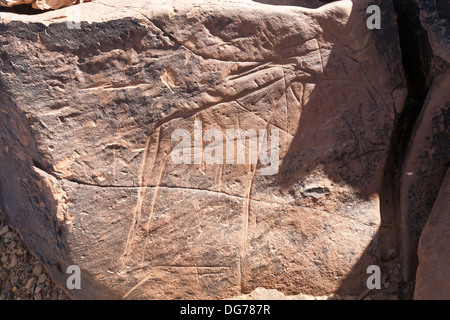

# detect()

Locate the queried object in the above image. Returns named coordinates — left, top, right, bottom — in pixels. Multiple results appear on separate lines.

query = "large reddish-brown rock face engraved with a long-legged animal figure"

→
left=0, top=0, right=406, bottom=299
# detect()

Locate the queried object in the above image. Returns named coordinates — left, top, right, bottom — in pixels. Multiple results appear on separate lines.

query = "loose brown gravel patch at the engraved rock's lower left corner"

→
left=0, top=211, right=70, bottom=300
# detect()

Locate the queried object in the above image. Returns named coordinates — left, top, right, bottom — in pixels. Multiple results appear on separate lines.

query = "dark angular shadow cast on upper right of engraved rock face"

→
left=278, top=1, right=406, bottom=200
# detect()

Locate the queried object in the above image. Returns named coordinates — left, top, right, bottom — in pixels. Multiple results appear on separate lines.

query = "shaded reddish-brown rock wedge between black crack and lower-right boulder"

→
left=400, top=71, right=450, bottom=279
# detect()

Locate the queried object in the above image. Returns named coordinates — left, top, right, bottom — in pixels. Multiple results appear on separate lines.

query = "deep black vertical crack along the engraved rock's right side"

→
left=380, top=0, right=431, bottom=300
